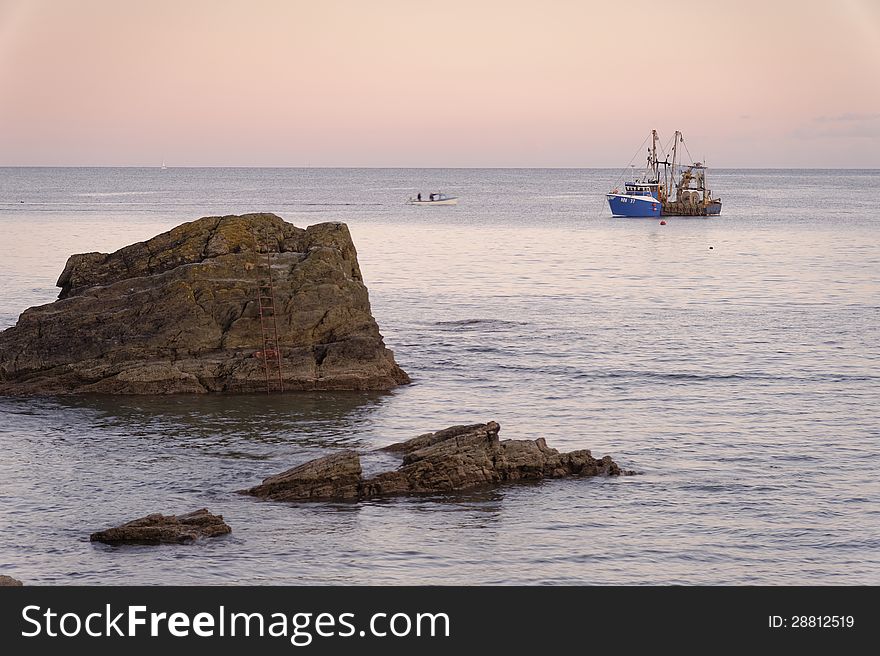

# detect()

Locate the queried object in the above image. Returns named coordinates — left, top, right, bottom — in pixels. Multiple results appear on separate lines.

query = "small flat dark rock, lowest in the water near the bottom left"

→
left=89, top=508, right=232, bottom=544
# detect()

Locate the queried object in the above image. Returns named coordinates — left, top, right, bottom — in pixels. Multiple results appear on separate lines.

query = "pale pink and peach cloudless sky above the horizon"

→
left=0, top=0, right=880, bottom=168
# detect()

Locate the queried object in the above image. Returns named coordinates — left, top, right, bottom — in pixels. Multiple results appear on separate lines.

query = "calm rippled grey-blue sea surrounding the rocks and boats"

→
left=0, top=168, right=880, bottom=585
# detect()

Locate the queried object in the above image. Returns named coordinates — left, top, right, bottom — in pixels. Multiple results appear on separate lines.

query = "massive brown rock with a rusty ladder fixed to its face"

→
left=0, top=214, right=409, bottom=395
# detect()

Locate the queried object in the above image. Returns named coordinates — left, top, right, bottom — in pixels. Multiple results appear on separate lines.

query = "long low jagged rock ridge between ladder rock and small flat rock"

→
left=241, top=421, right=631, bottom=501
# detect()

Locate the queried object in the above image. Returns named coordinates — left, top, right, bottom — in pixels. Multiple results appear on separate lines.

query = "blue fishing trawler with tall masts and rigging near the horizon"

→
left=605, top=130, right=721, bottom=217
